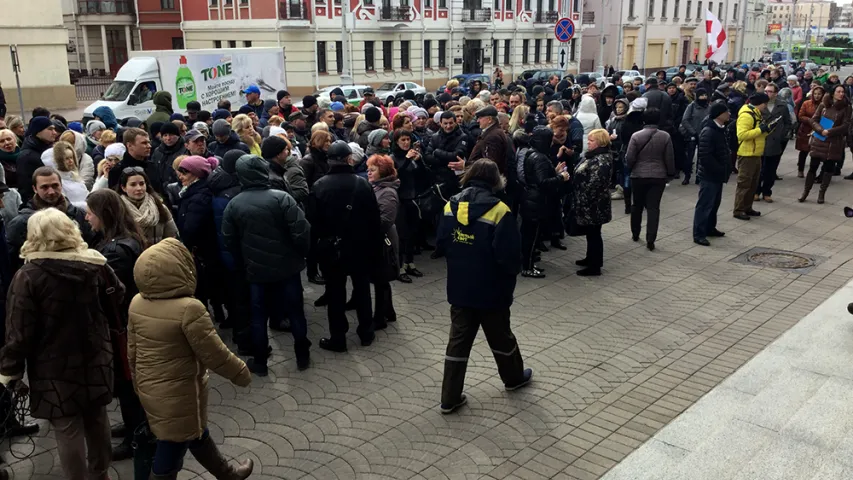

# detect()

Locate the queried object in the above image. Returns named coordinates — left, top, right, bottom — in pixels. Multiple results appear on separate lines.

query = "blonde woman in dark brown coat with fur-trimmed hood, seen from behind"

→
left=0, top=208, right=124, bottom=479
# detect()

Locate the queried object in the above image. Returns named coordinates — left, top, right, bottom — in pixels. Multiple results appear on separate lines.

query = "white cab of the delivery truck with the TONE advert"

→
left=83, top=57, right=163, bottom=124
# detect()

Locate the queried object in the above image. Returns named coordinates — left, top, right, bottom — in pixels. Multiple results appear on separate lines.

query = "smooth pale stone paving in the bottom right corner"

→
left=603, top=276, right=853, bottom=480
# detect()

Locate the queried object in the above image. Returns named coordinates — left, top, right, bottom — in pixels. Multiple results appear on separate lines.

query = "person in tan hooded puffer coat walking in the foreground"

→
left=128, top=238, right=253, bottom=480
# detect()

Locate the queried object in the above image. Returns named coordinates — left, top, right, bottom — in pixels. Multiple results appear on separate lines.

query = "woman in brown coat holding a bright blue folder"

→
left=798, top=85, right=851, bottom=203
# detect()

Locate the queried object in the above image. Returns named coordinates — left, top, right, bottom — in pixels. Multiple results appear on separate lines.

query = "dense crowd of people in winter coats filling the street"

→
left=0, top=59, right=853, bottom=479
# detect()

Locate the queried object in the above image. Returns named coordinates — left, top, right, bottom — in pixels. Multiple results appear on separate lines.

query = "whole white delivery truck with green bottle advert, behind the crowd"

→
left=83, top=47, right=287, bottom=122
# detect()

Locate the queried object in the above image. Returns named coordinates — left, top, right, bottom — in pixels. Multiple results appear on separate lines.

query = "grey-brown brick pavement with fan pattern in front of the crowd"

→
left=4, top=145, right=853, bottom=480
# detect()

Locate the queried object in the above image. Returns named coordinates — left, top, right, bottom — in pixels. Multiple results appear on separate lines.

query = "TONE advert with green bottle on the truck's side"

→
left=157, top=49, right=286, bottom=112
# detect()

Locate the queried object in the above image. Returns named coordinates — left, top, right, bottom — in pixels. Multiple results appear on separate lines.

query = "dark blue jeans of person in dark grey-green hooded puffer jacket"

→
left=250, top=273, right=308, bottom=363
